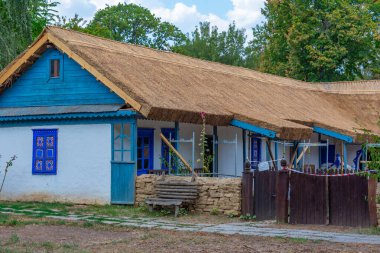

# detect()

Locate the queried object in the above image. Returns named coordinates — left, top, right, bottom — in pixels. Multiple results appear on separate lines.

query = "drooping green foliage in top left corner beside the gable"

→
left=0, top=0, right=58, bottom=70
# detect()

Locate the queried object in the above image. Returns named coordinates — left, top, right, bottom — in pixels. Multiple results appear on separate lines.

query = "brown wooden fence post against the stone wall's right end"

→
left=241, top=162, right=253, bottom=216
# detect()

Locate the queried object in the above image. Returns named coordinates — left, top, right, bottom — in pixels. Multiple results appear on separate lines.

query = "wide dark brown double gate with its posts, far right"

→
left=277, top=173, right=377, bottom=227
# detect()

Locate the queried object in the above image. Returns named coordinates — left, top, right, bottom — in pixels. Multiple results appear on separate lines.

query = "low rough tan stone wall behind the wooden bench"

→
left=136, top=175, right=241, bottom=215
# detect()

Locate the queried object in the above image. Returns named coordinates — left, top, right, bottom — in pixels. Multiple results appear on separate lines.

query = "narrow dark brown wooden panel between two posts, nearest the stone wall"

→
left=254, top=169, right=277, bottom=220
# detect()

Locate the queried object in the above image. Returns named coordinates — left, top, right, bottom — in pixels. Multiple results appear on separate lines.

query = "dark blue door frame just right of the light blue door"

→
left=137, top=128, right=154, bottom=176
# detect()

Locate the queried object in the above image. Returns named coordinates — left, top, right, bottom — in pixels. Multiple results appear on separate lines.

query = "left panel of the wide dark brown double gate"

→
left=289, top=173, right=327, bottom=224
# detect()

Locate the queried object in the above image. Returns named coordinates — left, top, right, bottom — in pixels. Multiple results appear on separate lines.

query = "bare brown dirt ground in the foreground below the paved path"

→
left=0, top=225, right=379, bottom=253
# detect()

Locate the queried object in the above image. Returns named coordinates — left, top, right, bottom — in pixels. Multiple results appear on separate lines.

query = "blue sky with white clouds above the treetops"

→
left=58, top=0, right=265, bottom=37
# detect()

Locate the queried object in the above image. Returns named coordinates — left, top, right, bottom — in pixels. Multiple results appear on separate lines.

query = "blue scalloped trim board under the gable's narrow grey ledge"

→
left=0, top=110, right=136, bottom=123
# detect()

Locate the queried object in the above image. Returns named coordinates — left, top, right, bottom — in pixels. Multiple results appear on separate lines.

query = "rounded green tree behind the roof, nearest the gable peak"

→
left=85, top=3, right=185, bottom=50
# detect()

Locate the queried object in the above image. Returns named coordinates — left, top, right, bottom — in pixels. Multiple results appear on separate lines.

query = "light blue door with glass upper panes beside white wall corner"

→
left=111, top=122, right=136, bottom=204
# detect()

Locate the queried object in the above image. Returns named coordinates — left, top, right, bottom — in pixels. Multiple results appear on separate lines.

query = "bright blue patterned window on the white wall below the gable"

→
left=32, top=129, right=58, bottom=175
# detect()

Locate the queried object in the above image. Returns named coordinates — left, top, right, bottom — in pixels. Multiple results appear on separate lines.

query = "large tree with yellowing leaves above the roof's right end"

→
left=247, top=0, right=380, bottom=81
